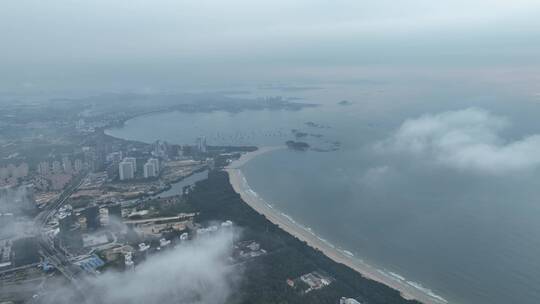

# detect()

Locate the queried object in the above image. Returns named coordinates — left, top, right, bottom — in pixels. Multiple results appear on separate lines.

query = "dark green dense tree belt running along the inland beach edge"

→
left=188, top=171, right=418, bottom=304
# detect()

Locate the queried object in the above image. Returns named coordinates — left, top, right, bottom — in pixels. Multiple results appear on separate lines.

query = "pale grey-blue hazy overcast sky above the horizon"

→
left=0, top=0, right=540, bottom=91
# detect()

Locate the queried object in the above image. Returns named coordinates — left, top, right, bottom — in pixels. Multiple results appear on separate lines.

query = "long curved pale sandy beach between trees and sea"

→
left=225, top=146, right=448, bottom=304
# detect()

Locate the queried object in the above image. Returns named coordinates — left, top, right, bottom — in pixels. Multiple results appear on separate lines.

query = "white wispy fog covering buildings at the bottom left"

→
left=41, top=231, right=241, bottom=304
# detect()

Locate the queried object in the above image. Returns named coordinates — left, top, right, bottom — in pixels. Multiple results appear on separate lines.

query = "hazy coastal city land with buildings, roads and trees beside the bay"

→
left=0, top=95, right=403, bottom=304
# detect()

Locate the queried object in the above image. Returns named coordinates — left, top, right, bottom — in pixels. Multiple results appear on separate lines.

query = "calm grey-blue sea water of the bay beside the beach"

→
left=108, top=84, right=540, bottom=304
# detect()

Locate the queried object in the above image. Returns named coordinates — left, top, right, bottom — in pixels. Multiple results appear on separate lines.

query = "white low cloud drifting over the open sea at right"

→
left=376, top=108, right=540, bottom=174
